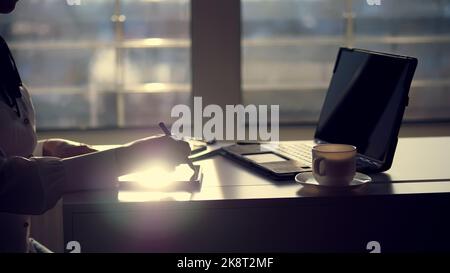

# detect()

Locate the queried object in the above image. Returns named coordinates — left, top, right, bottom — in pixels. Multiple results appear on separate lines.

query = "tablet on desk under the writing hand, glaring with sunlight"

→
left=119, top=164, right=203, bottom=192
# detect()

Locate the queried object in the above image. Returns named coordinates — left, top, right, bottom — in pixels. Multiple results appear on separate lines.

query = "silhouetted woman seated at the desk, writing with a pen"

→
left=0, top=0, right=190, bottom=252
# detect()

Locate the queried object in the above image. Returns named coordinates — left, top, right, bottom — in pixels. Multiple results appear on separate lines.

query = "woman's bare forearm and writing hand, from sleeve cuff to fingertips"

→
left=62, top=133, right=191, bottom=191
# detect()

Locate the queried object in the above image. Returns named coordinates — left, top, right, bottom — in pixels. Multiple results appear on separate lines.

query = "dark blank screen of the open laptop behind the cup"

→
left=315, top=48, right=415, bottom=161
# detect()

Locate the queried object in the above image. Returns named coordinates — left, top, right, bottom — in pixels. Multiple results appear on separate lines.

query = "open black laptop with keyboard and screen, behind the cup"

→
left=223, top=48, right=417, bottom=179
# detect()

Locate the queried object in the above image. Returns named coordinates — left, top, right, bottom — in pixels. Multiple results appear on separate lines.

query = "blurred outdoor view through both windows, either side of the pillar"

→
left=0, top=0, right=450, bottom=130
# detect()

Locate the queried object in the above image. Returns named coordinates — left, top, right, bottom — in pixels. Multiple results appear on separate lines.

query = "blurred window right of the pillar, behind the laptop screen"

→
left=242, top=0, right=450, bottom=123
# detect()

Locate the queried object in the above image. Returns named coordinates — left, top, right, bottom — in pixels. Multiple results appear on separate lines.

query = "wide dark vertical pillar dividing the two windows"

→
left=191, top=0, right=242, bottom=108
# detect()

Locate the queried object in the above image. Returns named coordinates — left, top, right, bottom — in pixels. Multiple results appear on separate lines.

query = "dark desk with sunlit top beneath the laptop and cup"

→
left=63, top=138, right=450, bottom=252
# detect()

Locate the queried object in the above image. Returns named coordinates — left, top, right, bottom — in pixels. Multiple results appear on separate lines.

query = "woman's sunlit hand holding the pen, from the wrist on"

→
left=116, top=136, right=191, bottom=174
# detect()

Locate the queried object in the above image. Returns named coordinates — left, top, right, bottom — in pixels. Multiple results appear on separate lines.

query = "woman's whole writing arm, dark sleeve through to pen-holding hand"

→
left=0, top=137, right=190, bottom=214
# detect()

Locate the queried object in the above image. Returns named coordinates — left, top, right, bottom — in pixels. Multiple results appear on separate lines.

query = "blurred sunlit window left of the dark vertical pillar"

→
left=0, top=0, right=190, bottom=129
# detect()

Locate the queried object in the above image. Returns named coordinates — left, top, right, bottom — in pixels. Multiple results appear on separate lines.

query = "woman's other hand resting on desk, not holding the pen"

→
left=42, top=139, right=97, bottom=158
